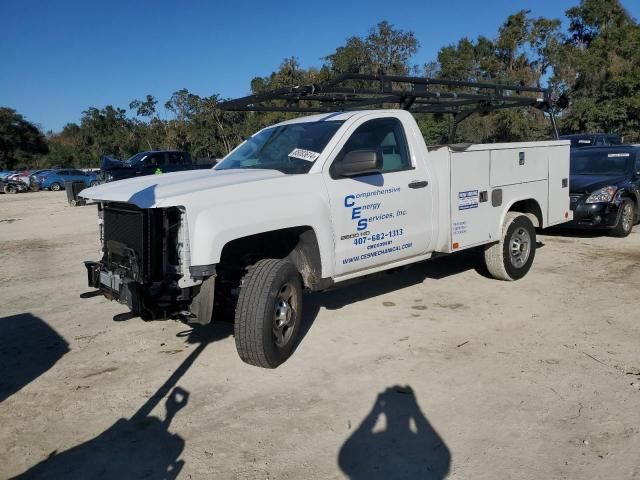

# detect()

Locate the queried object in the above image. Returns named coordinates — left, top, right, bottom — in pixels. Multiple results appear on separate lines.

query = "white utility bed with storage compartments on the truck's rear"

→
left=430, top=140, right=571, bottom=253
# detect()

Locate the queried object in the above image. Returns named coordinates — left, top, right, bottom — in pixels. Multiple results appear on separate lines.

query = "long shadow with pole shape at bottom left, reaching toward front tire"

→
left=9, top=318, right=220, bottom=480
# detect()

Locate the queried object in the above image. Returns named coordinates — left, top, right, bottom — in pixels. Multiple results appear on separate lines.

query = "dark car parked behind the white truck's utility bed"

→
left=567, top=145, right=640, bottom=237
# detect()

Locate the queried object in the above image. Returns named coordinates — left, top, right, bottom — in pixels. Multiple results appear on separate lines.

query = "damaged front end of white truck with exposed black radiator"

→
left=85, top=202, right=215, bottom=323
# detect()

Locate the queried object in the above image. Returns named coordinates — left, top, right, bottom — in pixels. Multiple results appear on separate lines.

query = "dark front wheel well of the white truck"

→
left=219, top=226, right=322, bottom=289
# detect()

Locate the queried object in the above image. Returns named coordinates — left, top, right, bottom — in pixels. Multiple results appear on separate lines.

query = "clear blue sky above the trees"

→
left=0, top=0, right=640, bottom=131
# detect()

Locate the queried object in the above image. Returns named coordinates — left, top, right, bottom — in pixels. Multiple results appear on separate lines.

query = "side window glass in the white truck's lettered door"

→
left=336, top=117, right=412, bottom=173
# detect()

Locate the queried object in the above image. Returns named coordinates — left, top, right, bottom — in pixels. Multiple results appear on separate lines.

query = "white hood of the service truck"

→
left=79, top=169, right=285, bottom=208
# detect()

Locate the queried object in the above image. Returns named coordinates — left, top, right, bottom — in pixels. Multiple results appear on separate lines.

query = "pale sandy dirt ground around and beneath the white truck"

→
left=0, top=192, right=640, bottom=480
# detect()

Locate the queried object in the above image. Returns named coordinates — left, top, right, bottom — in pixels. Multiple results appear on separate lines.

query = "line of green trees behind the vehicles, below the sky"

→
left=0, top=0, right=640, bottom=168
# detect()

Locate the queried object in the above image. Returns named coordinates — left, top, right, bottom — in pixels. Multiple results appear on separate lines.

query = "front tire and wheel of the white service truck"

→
left=234, top=258, right=302, bottom=368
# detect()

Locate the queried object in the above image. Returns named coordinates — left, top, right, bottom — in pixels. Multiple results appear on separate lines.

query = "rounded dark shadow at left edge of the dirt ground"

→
left=0, top=313, right=69, bottom=402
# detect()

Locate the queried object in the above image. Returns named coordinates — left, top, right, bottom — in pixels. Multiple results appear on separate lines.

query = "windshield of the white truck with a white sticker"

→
left=216, top=121, right=343, bottom=173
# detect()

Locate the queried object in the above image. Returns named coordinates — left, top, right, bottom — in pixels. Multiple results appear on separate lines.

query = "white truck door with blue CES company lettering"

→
left=323, top=114, right=433, bottom=276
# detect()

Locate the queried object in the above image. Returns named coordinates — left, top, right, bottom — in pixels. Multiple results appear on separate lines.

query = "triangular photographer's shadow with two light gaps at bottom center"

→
left=338, top=386, right=451, bottom=480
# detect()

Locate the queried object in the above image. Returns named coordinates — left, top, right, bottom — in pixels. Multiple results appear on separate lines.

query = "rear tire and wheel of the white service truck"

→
left=484, top=212, right=536, bottom=281
